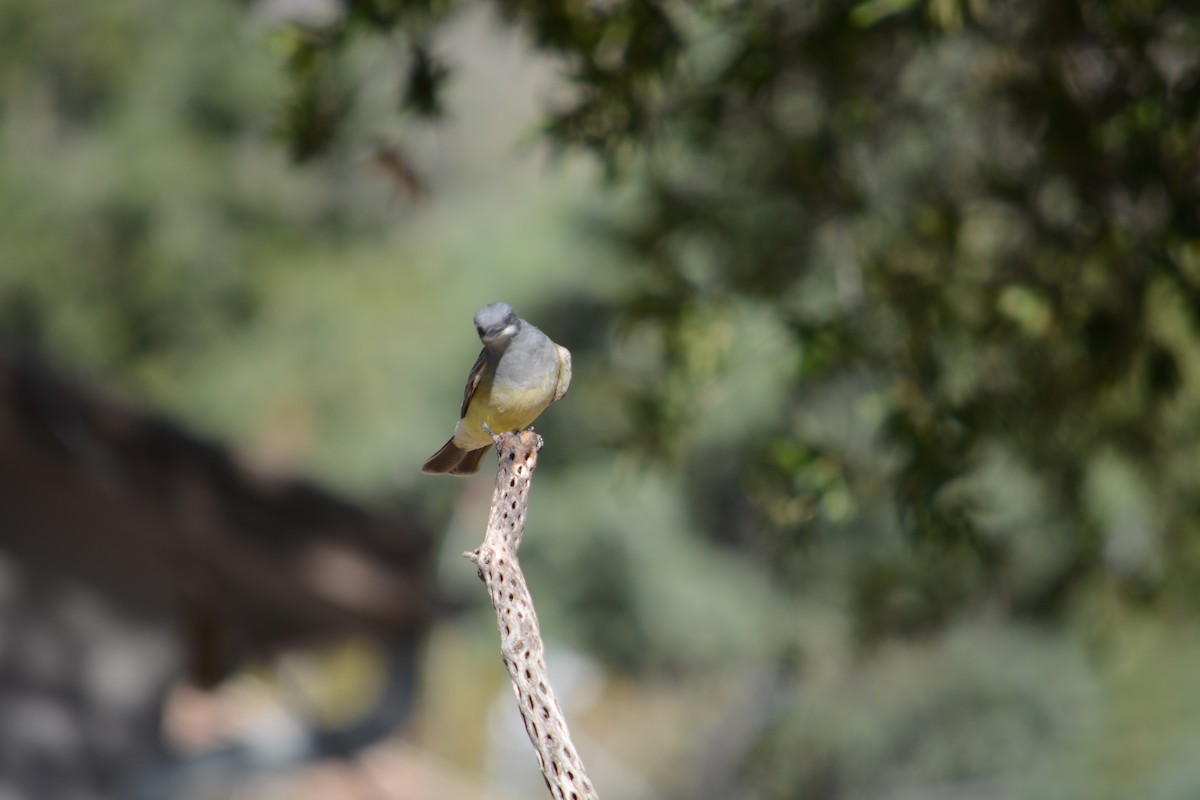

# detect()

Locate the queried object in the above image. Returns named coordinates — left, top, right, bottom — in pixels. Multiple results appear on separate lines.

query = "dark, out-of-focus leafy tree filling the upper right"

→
left=276, top=0, right=1200, bottom=639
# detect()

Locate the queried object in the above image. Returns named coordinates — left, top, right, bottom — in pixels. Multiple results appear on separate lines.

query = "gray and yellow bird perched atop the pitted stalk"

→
left=421, top=302, right=571, bottom=475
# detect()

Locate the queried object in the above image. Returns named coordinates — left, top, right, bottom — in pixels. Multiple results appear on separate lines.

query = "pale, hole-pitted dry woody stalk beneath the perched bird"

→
left=463, top=431, right=598, bottom=800
